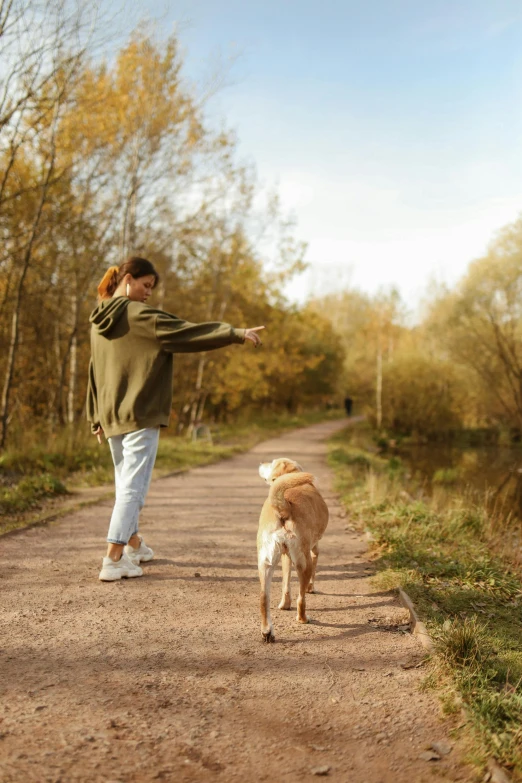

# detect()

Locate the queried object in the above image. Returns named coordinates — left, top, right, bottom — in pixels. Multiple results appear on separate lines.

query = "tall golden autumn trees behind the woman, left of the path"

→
left=0, top=0, right=342, bottom=447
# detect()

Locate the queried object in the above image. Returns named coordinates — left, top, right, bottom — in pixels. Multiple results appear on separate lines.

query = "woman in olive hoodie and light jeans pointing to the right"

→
left=87, top=257, right=264, bottom=582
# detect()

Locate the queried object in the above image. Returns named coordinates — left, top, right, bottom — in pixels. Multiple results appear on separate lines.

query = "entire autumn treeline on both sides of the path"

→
left=0, top=0, right=522, bottom=448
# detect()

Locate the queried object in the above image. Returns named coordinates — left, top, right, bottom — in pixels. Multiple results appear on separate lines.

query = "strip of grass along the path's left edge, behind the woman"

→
left=0, top=411, right=342, bottom=535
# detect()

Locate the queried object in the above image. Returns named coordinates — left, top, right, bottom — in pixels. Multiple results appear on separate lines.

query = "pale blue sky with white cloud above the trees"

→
left=120, top=0, right=522, bottom=309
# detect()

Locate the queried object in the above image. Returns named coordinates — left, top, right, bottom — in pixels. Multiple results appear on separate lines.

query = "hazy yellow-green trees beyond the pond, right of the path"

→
left=310, top=218, right=522, bottom=441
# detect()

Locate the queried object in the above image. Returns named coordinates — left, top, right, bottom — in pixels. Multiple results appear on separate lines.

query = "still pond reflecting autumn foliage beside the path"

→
left=398, top=443, right=522, bottom=520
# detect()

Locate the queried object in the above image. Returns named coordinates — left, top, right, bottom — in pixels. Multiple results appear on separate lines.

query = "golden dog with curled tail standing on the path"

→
left=257, top=458, right=328, bottom=642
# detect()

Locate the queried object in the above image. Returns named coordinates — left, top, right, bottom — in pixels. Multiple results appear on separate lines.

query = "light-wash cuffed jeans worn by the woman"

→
left=107, top=427, right=159, bottom=544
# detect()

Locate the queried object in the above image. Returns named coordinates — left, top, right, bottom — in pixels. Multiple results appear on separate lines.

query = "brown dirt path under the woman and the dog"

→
left=0, top=422, right=470, bottom=783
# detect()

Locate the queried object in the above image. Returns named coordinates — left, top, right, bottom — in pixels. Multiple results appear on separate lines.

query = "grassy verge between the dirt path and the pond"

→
left=329, top=426, right=522, bottom=781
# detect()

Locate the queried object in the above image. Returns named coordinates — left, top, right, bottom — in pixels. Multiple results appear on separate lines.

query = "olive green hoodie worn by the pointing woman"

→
left=87, top=296, right=245, bottom=438
